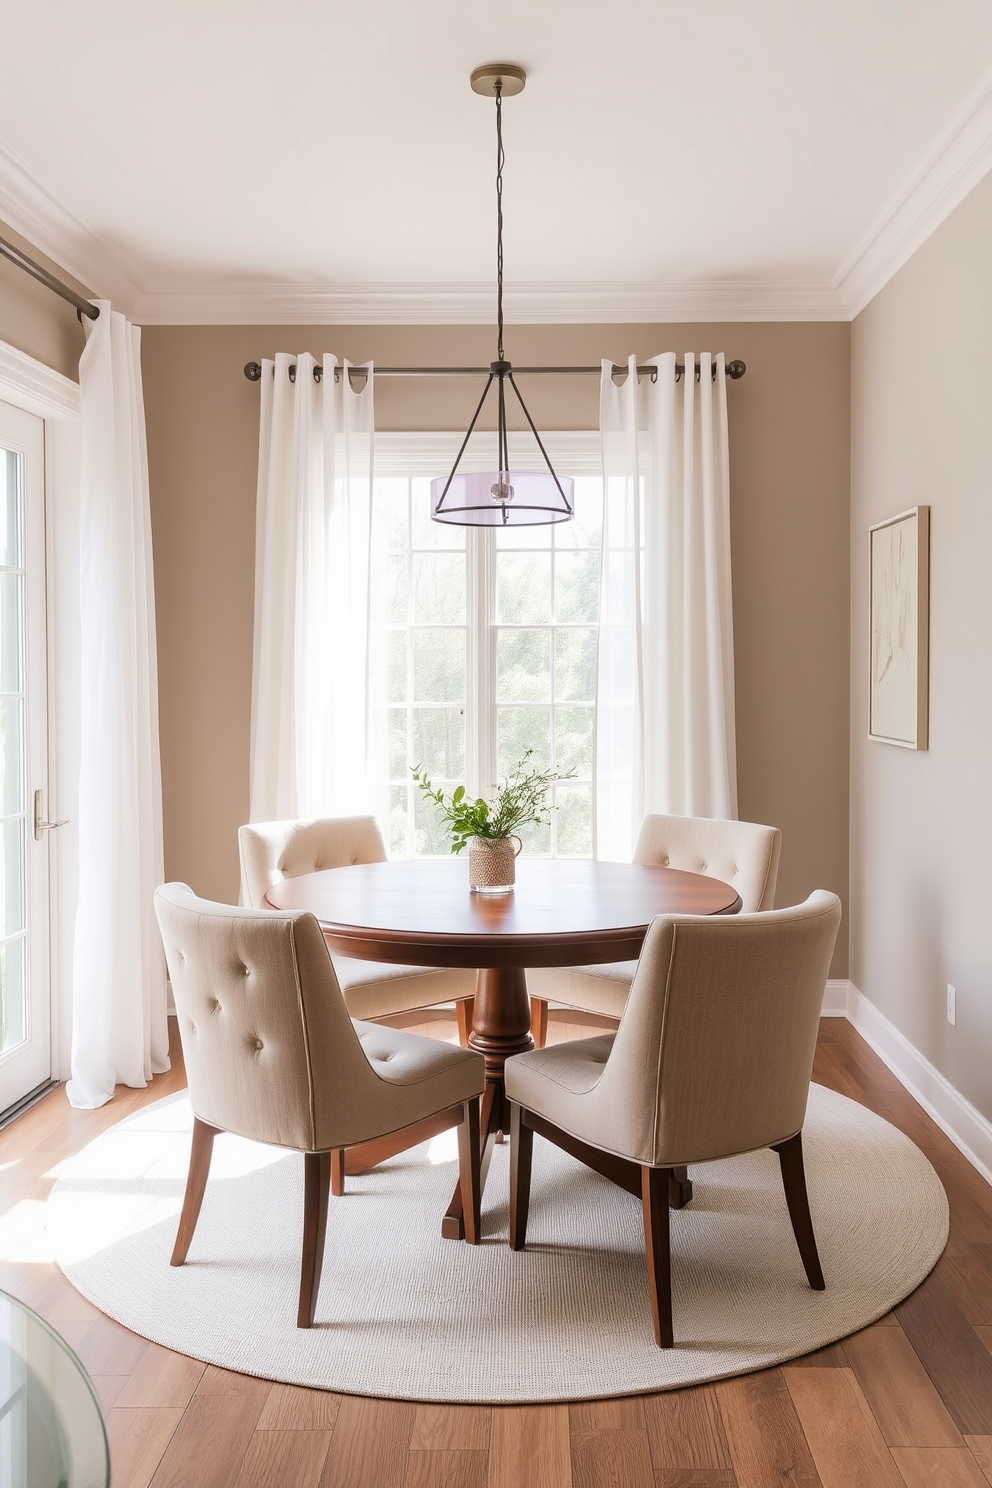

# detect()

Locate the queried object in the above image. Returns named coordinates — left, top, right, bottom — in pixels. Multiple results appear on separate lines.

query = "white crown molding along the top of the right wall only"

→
left=833, top=62, right=992, bottom=320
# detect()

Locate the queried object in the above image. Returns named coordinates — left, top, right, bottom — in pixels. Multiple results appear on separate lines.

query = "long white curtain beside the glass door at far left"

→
left=67, top=301, right=170, bottom=1106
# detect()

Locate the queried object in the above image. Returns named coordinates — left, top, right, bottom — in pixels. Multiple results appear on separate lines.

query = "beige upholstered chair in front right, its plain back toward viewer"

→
left=504, top=890, right=840, bottom=1348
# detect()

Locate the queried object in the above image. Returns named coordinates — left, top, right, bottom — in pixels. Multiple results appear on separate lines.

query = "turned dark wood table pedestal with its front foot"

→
left=440, top=966, right=534, bottom=1240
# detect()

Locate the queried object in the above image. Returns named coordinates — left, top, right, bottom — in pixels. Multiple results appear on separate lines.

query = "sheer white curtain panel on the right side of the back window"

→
left=595, top=353, right=738, bottom=860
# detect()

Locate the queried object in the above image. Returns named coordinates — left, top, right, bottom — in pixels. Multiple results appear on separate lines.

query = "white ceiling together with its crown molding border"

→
left=0, top=0, right=992, bottom=323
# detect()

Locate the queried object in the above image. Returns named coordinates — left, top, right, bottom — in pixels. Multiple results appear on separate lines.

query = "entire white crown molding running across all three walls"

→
left=0, top=57, right=992, bottom=326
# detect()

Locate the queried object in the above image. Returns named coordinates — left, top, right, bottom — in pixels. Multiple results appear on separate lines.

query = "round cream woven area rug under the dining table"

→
left=48, top=1085, right=947, bottom=1403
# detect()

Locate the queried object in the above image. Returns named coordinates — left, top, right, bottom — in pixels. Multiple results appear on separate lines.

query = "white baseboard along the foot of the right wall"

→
left=822, top=981, right=992, bottom=1183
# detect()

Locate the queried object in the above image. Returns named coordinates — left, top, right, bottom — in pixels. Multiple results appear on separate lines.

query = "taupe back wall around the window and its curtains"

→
left=143, top=324, right=849, bottom=976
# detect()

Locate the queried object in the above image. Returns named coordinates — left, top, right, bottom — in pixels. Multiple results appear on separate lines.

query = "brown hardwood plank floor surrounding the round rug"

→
left=0, top=1013, right=992, bottom=1488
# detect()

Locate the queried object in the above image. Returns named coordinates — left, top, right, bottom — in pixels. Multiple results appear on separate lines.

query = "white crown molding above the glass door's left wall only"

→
left=0, top=143, right=141, bottom=315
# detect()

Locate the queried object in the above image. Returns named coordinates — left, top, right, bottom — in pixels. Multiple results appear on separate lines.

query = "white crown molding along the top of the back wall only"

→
left=132, top=280, right=848, bottom=326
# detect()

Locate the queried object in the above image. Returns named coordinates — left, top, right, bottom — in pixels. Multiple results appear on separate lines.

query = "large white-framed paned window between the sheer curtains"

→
left=370, top=434, right=602, bottom=857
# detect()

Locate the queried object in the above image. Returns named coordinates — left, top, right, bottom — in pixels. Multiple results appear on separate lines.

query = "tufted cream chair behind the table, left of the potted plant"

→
left=238, top=817, right=476, bottom=1049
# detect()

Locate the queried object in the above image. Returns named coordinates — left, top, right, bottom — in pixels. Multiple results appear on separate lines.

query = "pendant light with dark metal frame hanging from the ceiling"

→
left=431, top=62, right=574, bottom=527
